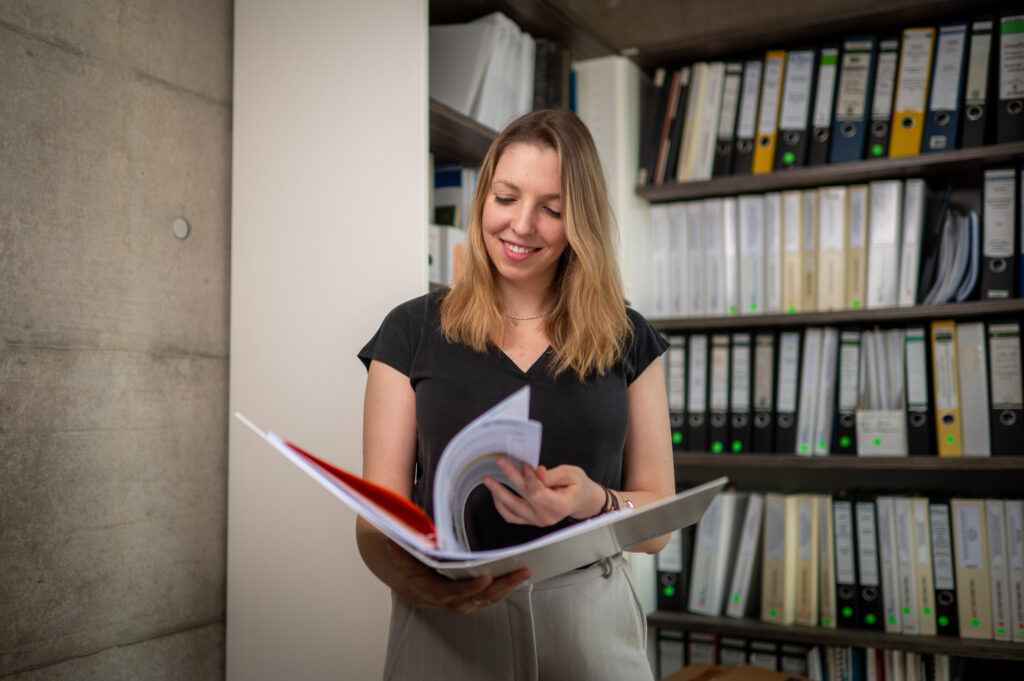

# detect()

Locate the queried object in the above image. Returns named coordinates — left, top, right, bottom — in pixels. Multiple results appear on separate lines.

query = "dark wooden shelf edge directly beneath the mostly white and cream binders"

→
left=650, top=298, right=1024, bottom=331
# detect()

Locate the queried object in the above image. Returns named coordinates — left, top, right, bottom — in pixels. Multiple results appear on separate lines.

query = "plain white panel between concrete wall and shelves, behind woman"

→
left=227, top=0, right=428, bottom=681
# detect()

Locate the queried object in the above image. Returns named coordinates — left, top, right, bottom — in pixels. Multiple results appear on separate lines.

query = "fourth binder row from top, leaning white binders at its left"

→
left=655, top=492, right=1024, bottom=643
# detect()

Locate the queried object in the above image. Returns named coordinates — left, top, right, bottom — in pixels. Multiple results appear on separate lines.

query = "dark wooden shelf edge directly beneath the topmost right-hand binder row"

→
left=636, top=142, right=1024, bottom=203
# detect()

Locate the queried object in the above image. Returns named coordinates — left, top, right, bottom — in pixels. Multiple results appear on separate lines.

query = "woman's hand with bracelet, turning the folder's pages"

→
left=483, top=458, right=605, bottom=527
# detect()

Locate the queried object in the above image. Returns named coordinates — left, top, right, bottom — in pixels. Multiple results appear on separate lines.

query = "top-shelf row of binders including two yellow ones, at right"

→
left=638, top=11, right=1024, bottom=184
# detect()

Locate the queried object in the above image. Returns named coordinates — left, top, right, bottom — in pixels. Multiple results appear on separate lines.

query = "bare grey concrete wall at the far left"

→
left=0, top=0, right=232, bottom=681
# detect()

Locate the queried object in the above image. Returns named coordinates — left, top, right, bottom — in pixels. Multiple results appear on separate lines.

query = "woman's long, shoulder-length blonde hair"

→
left=440, top=109, right=633, bottom=380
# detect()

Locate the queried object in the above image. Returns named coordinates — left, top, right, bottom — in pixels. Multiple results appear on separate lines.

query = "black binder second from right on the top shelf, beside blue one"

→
left=961, top=16, right=998, bottom=147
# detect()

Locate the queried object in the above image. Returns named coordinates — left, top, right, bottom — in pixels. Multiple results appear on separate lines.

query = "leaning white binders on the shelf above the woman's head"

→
left=429, top=12, right=569, bottom=130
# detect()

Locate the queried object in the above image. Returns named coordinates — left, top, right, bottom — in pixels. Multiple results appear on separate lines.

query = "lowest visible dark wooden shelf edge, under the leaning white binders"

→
left=647, top=611, right=1024, bottom=661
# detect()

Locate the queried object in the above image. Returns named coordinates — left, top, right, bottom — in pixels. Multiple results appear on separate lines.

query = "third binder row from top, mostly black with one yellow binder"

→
left=664, top=318, right=1024, bottom=457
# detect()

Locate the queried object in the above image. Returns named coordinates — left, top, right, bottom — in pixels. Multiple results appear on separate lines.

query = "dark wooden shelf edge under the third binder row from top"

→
left=675, top=452, right=1024, bottom=471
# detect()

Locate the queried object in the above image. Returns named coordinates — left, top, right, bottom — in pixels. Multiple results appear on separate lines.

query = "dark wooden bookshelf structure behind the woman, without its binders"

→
left=429, top=0, right=1024, bottom=678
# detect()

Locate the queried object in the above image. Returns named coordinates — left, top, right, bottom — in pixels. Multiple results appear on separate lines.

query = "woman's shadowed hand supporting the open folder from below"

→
left=382, top=536, right=529, bottom=614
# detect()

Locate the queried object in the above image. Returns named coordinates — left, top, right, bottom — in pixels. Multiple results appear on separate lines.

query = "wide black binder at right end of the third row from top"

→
left=987, top=320, right=1024, bottom=456
